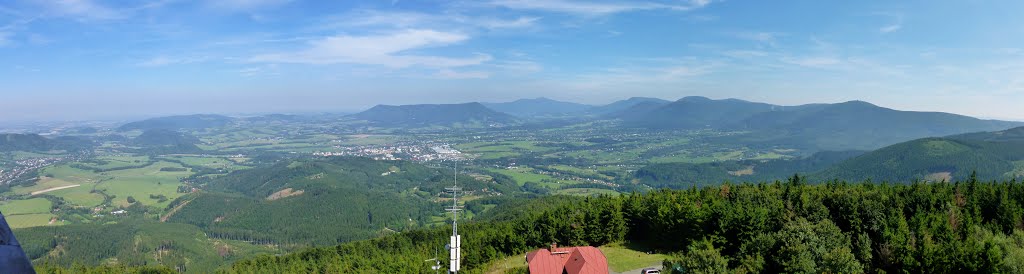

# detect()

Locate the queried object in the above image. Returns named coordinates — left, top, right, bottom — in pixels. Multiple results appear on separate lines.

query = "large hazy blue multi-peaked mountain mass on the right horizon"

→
left=613, top=97, right=1024, bottom=150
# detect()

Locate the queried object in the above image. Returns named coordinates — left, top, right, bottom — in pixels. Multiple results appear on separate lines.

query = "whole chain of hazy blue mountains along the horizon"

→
left=108, top=96, right=1024, bottom=151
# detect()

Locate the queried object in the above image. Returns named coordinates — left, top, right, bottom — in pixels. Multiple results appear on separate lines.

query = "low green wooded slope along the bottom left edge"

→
left=15, top=217, right=269, bottom=273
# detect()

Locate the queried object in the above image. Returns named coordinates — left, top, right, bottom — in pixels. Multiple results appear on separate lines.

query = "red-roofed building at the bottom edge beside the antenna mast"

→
left=526, top=244, right=608, bottom=274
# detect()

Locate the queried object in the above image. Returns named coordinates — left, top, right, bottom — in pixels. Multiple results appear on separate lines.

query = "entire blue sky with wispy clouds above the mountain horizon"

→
left=0, top=0, right=1024, bottom=122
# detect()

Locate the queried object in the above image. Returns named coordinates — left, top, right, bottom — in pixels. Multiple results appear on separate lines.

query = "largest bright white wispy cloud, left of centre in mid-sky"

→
left=250, top=30, right=492, bottom=69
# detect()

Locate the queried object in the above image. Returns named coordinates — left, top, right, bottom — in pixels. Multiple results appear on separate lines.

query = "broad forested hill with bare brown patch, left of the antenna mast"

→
left=168, top=157, right=518, bottom=245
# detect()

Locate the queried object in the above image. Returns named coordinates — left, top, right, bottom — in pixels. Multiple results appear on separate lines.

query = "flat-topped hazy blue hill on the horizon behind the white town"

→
left=349, top=102, right=516, bottom=128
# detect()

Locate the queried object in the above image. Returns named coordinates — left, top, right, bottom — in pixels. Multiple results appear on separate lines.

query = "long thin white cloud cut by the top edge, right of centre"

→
left=488, top=0, right=712, bottom=16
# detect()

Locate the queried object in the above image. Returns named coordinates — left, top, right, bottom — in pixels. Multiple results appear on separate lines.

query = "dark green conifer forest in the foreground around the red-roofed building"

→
left=226, top=178, right=1024, bottom=273
